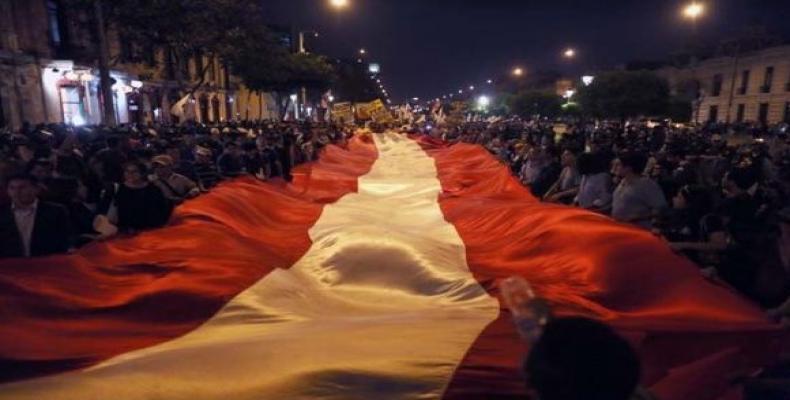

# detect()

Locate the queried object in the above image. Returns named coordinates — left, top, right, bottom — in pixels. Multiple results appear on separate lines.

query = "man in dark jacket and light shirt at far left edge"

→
left=0, top=175, right=70, bottom=258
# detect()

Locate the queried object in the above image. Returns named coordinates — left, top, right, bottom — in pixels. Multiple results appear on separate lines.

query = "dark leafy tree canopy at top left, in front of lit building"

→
left=64, top=0, right=296, bottom=122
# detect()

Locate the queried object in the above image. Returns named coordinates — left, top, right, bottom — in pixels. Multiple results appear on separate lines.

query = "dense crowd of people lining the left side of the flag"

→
left=0, top=121, right=352, bottom=258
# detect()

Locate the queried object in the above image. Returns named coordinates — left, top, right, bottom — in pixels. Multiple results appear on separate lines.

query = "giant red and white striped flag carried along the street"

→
left=0, top=133, right=783, bottom=400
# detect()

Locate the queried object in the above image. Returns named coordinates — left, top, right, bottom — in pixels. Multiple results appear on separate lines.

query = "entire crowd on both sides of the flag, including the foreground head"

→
left=0, top=118, right=790, bottom=400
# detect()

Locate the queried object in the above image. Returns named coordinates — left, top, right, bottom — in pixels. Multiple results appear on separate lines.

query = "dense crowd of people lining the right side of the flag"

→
left=423, top=118, right=790, bottom=316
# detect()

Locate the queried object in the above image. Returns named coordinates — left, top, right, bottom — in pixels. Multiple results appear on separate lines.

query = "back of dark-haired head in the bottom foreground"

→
left=524, top=318, right=640, bottom=400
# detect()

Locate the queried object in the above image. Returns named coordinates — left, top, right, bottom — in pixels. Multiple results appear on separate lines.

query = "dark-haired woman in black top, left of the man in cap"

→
left=115, top=162, right=173, bottom=233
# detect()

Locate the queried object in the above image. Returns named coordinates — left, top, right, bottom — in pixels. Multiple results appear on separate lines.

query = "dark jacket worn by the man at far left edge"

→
left=0, top=201, right=71, bottom=258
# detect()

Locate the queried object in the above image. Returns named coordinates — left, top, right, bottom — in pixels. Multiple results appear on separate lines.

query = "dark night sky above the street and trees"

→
left=263, top=0, right=790, bottom=100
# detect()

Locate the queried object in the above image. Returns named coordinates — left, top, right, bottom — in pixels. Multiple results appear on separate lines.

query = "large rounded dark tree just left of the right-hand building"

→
left=577, top=71, right=669, bottom=119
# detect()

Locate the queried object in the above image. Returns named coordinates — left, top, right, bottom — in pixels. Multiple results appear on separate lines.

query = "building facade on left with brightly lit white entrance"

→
left=0, top=0, right=278, bottom=129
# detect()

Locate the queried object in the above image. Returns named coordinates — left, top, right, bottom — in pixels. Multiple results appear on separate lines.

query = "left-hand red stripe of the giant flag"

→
left=0, top=138, right=377, bottom=382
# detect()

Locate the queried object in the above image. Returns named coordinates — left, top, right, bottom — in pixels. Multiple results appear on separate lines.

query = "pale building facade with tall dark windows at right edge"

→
left=658, top=46, right=790, bottom=124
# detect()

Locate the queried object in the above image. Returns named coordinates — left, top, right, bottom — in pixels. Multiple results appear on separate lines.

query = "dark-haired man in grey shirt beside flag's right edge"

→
left=612, top=153, right=667, bottom=229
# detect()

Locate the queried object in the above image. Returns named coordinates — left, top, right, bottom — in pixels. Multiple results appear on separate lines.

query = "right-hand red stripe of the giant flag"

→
left=415, top=137, right=783, bottom=400
